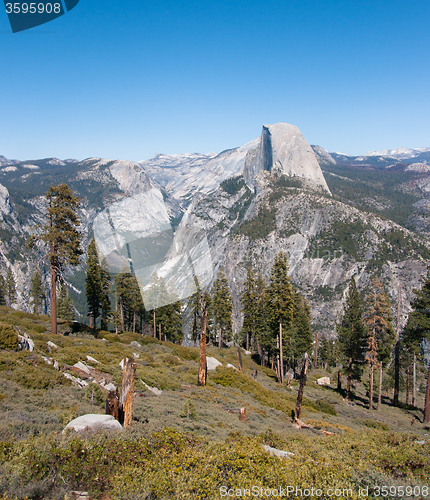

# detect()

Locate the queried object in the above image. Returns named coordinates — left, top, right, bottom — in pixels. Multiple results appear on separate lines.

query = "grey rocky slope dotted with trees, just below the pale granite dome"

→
left=183, top=171, right=430, bottom=335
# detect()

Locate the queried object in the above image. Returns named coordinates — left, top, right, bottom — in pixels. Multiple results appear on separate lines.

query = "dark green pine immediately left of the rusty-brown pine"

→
left=336, top=277, right=367, bottom=400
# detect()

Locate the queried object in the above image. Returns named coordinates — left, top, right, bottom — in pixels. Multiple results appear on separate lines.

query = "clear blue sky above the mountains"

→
left=0, top=0, right=430, bottom=161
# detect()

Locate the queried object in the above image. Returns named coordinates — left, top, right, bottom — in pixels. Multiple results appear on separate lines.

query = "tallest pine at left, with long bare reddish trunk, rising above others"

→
left=29, top=183, right=82, bottom=334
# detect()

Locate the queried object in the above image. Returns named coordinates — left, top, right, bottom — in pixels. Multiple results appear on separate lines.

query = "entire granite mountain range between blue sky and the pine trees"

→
left=0, top=124, right=430, bottom=334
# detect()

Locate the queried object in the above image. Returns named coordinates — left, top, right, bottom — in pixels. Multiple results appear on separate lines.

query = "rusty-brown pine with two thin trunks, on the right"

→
left=364, top=277, right=395, bottom=410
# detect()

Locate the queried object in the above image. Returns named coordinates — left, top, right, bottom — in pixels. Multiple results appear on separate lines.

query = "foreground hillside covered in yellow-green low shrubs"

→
left=0, top=307, right=430, bottom=500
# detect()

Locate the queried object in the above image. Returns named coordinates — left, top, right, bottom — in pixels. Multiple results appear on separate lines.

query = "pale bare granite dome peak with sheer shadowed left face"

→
left=244, top=123, right=330, bottom=192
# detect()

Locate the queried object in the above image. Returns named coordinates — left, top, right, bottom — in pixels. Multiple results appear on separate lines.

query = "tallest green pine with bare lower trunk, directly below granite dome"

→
left=267, top=252, right=294, bottom=384
